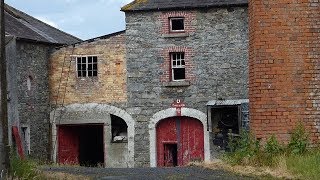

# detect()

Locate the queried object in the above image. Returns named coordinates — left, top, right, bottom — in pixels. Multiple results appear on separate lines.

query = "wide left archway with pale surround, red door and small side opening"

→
left=50, top=103, right=135, bottom=167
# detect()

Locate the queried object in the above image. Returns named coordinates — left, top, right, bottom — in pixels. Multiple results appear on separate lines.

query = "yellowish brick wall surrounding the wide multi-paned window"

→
left=49, top=33, right=127, bottom=105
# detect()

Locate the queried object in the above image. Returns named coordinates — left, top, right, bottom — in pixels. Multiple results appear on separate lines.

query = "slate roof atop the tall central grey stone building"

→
left=121, top=0, right=248, bottom=12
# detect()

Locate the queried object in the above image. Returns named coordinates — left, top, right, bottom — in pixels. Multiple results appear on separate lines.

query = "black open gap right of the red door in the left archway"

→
left=79, top=126, right=104, bottom=167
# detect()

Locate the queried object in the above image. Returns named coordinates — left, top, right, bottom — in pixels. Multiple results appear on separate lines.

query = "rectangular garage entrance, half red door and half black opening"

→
left=58, top=124, right=104, bottom=167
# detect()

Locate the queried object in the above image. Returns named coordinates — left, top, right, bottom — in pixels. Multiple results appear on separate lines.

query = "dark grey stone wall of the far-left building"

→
left=15, top=41, right=53, bottom=159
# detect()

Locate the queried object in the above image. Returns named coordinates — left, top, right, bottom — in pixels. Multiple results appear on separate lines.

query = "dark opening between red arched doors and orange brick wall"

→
left=211, top=105, right=240, bottom=151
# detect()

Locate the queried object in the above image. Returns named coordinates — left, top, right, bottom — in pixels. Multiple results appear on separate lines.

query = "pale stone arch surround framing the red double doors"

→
left=149, top=108, right=210, bottom=167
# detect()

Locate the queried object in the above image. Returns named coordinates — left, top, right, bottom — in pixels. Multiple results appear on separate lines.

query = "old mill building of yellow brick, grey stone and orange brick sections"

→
left=0, top=0, right=320, bottom=170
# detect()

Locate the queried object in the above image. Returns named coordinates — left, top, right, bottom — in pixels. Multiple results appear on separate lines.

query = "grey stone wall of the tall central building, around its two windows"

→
left=126, top=7, right=248, bottom=166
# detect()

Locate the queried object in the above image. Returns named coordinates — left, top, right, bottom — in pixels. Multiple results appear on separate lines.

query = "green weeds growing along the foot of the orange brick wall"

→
left=224, top=123, right=309, bottom=167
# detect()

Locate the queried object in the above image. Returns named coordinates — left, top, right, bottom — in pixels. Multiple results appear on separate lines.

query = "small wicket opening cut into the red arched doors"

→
left=164, top=144, right=178, bottom=167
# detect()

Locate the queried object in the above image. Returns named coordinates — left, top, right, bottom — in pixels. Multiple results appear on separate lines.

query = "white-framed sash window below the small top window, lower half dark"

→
left=171, top=52, right=186, bottom=81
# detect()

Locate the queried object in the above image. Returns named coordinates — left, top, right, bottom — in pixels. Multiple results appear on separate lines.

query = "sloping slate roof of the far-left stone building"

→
left=5, top=4, right=81, bottom=45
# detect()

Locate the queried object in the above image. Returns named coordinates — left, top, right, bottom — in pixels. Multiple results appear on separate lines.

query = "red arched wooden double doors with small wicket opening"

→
left=156, top=116, right=204, bottom=167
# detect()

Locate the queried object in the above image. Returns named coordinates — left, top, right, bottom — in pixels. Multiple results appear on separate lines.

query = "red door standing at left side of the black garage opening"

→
left=58, top=126, right=79, bottom=164
